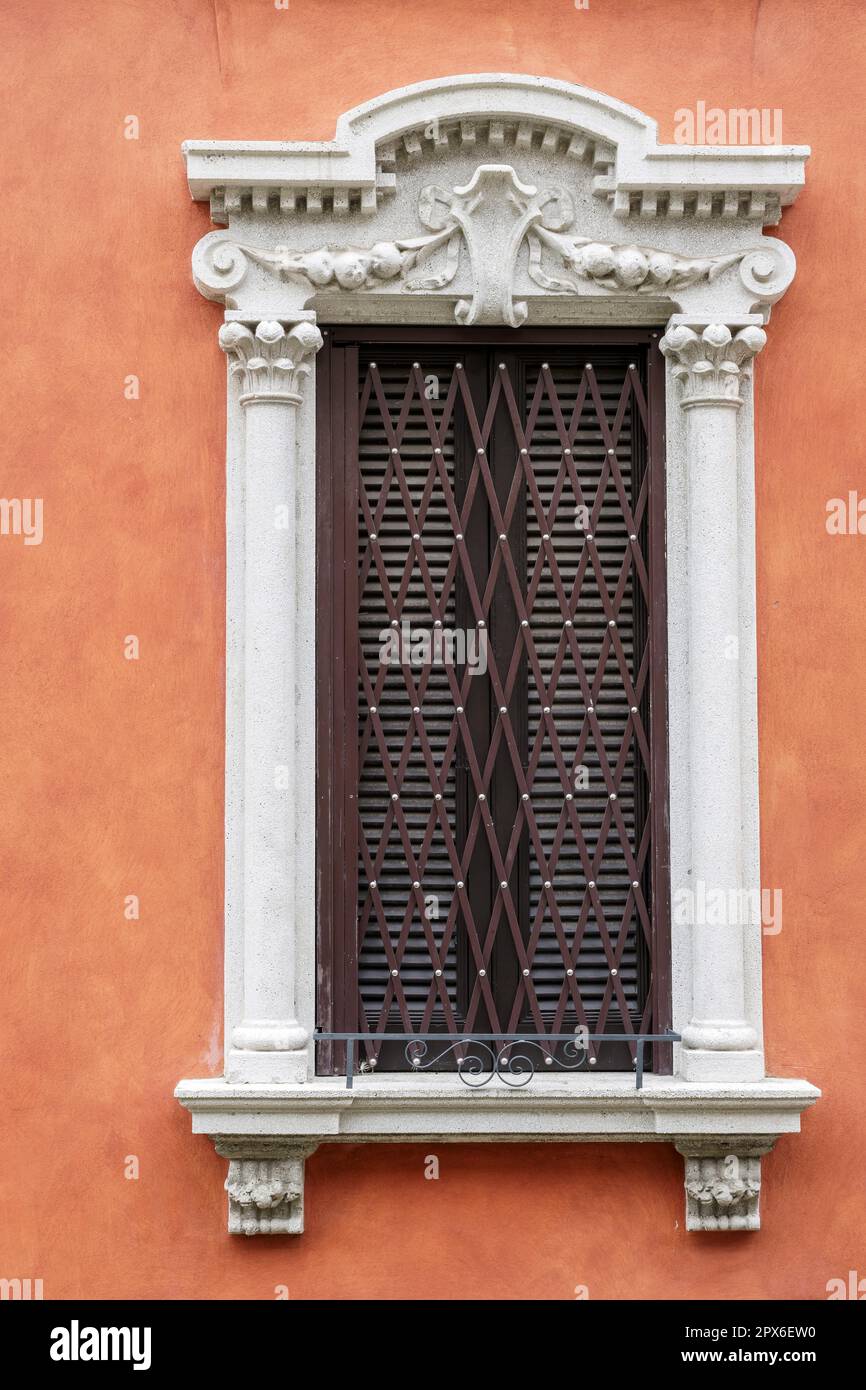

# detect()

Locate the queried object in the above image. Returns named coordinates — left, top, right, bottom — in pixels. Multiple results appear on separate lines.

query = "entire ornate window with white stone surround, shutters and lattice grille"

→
left=177, top=75, right=817, bottom=1234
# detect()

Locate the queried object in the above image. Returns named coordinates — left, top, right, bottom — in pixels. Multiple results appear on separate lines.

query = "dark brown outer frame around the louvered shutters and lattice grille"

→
left=316, top=325, right=673, bottom=1074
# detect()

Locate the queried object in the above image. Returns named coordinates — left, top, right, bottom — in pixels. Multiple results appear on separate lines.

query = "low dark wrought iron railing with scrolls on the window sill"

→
left=314, top=1030, right=680, bottom=1091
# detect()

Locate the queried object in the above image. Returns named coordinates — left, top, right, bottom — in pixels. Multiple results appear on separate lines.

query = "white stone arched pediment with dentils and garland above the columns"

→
left=183, top=74, right=809, bottom=327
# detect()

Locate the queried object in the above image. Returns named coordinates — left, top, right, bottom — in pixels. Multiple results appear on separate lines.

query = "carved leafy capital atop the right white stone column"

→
left=659, top=324, right=767, bottom=409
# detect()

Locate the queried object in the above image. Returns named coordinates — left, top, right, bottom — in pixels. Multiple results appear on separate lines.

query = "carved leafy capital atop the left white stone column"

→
left=220, top=318, right=322, bottom=406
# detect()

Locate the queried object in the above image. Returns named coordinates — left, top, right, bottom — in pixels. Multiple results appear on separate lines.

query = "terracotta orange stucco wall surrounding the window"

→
left=0, top=0, right=866, bottom=1298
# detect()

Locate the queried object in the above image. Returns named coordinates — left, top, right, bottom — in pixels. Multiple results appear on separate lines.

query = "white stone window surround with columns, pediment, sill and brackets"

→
left=175, top=74, right=819, bottom=1234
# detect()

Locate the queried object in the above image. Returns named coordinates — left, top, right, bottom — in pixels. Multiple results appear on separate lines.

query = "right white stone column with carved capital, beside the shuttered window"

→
left=660, top=322, right=766, bottom=1081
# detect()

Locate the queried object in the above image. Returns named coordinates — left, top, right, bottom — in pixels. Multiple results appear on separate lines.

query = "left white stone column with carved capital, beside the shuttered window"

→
left=220, top=320, right=322, bottom=1083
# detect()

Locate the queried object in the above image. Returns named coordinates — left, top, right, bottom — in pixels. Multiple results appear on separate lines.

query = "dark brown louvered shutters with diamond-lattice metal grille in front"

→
left=318, top=335, right=667, bottom=1069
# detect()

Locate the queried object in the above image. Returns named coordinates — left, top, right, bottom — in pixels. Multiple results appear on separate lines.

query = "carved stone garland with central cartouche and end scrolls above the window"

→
left=193, top=164, right=794, bottom=328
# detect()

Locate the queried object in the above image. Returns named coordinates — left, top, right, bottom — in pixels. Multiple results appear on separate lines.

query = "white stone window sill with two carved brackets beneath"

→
left=175, top=1074, right=820, bottom=1236
